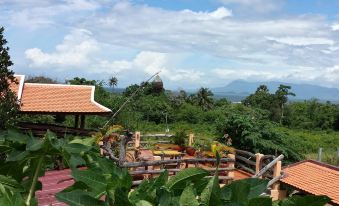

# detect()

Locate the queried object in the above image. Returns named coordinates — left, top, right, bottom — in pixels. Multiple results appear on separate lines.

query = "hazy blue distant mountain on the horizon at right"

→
left=211, top=80, right=339, bottom=102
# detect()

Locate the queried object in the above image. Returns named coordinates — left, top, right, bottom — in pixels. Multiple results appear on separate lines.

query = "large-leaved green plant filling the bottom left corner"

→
left=0, top=130, right=94, bottom=206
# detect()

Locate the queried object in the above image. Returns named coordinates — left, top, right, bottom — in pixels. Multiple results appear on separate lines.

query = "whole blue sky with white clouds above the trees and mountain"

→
left=0, top=0, right=339, bottom=89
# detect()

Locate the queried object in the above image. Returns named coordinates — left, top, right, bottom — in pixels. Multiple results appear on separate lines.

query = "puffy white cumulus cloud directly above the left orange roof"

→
left=25, top=29, right=99, bottom=70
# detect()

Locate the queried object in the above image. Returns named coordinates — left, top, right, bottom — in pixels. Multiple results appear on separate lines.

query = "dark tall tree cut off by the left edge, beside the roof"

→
left=0, top=27, right=19, bottom=129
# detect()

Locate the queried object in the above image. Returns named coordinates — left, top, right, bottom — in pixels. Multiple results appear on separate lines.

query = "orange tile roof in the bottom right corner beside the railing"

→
left=281, top=160, right=339, bottom=204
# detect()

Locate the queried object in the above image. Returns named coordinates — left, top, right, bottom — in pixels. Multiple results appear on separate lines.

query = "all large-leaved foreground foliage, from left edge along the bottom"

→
left=0, top=131, right=329, bottom=206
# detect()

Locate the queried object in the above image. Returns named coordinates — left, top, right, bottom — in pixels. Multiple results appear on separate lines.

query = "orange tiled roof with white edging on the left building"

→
left=11, top=76, right=111, bottom=114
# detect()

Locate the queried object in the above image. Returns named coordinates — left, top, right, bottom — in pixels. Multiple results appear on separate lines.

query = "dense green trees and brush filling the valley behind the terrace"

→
left=13, top=77, right=339, bottom=164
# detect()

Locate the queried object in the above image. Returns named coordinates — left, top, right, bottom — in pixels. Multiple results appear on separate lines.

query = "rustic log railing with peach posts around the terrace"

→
left=101, top=132, right=284, bottom=194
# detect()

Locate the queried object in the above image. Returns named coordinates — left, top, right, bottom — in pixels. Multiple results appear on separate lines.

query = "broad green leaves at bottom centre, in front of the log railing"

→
left=57, top=150, right=329, bottom=206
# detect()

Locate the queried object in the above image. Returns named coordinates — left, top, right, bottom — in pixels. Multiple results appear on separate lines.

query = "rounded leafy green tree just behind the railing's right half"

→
left=217, top=107, right=302, bottom=161
